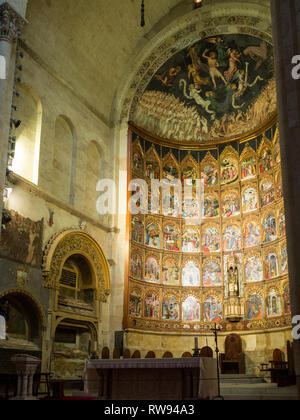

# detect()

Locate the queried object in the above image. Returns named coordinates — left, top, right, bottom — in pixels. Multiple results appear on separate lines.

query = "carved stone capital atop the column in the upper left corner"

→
left=0, top=3, right=26, bottom=42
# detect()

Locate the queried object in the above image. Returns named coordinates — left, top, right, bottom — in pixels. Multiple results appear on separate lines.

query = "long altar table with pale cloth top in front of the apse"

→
left=83, top=357, right=218, bottom=400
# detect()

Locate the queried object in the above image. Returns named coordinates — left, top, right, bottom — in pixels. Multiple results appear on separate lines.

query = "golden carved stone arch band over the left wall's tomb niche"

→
left=42, top=230, right=110, bottom=302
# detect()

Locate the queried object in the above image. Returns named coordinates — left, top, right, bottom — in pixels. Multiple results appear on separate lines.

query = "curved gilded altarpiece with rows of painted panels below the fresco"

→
left=125, top=120, right=290, bottom=332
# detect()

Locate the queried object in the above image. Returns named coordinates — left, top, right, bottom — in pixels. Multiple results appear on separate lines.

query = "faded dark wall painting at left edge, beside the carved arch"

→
left=0, top=210, right=44, bottom=268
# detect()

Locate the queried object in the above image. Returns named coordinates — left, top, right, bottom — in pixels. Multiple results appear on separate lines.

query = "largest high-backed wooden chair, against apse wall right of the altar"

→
left=220, top=334, right=245, bottom=374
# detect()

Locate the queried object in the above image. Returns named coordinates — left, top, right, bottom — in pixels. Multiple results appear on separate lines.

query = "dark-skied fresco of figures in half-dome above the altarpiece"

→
left=133, top=34, right=278, bottom=143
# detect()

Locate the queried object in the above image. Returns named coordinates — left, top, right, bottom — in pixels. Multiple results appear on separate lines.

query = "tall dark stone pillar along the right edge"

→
left=271, top=0, right=300, bottom=399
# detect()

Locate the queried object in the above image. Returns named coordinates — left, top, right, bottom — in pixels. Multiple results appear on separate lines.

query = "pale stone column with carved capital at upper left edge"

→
left=0, top=0, right=26, bottom=240
